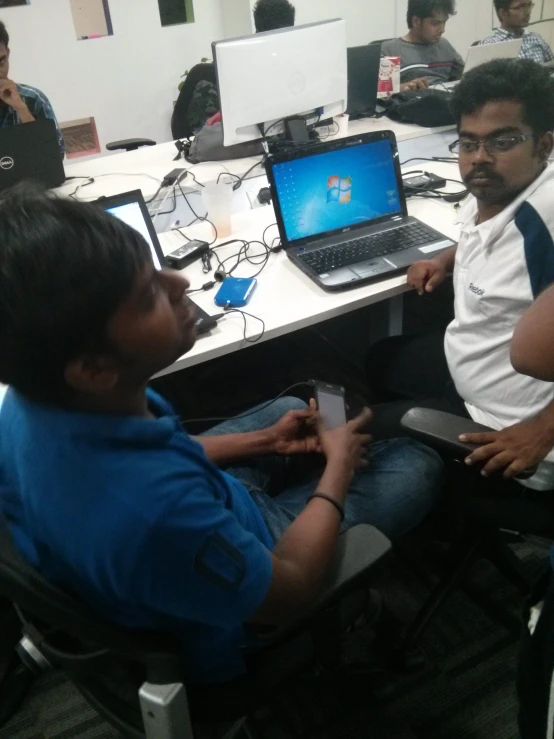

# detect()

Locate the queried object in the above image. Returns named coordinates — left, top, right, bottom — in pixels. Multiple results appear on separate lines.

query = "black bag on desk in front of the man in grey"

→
left=380, top=89, right=456, bottom=128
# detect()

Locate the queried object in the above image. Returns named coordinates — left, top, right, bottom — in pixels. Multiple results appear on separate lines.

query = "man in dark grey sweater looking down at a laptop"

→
left=381, top=0, right=464, bottom=89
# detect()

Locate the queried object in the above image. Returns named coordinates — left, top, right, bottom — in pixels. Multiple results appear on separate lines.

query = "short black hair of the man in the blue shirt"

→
left=0, top=185, right=151, bottom=405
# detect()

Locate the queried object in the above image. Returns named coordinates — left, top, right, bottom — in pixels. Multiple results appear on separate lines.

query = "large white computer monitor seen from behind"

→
left=212, top=19, right=348, bottom=146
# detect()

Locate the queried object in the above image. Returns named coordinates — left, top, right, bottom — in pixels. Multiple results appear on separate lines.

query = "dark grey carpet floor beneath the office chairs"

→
left=0, top=540, right=548, bottom=739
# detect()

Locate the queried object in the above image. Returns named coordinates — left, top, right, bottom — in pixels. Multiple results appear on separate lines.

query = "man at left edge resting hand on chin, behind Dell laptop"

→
left=0, top=21, right=65, bottom=156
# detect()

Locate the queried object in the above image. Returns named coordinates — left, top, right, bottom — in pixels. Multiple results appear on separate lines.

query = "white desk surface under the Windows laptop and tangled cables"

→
left=153, top=163, right=459, bottom=375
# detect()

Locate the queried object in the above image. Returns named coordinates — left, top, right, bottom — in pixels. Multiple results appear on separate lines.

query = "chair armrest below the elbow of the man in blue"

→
left=248, top=524, right=392, bottom=646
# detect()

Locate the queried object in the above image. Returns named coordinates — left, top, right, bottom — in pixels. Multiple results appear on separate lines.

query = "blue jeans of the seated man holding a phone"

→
left=206, top=398, right=444, bottom=541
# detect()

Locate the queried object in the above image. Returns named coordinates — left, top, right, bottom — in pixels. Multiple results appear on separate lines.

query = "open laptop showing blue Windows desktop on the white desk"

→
left=266, top=131, right=454, bottom=290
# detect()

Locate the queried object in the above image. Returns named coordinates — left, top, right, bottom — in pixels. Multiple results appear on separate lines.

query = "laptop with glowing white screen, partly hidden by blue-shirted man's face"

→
left=96, top=190, right=217, bottom=335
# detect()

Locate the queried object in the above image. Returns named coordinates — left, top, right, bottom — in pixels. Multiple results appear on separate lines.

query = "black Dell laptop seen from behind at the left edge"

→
left=0, top=118, right=65, bottom=190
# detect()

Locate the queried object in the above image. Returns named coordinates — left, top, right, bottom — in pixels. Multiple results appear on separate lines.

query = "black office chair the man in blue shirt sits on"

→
left=0, top=524, right=391, bottom=739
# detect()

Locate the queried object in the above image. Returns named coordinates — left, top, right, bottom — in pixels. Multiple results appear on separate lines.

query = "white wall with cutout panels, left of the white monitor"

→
left=0, top=0, right=225, bottom=150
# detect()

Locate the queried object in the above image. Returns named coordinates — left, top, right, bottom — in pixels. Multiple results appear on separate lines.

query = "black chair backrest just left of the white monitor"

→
left=171, top=62, right=219, bottom=139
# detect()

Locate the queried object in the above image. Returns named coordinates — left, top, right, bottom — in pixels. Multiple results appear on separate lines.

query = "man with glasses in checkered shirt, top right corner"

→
left=481, top=0, right=554, bottom=64
